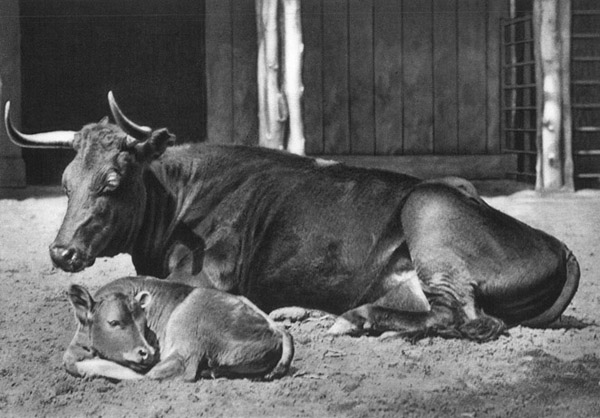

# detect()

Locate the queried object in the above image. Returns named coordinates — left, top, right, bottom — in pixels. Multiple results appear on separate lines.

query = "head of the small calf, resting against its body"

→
left=68, top=285, right=158, bottom=371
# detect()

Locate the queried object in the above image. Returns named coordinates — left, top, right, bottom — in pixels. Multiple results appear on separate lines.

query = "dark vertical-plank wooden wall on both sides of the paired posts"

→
left=206, top=0, right=509, bottom=155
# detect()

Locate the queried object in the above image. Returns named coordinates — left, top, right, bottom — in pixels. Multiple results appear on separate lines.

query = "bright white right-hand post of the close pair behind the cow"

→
left=283, top=0, right=306, bottom=155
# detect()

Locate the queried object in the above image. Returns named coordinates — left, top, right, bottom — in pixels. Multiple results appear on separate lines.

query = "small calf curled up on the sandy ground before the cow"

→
left=64, top=277, right=294, bottom=381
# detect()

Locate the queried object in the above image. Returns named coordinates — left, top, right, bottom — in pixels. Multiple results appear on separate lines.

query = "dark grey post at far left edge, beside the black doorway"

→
left=0, top=0, right=25, bottom=187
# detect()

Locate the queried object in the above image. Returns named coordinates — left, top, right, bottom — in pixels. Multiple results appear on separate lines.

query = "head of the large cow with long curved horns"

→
left=4, top=93, right=174, bottom=272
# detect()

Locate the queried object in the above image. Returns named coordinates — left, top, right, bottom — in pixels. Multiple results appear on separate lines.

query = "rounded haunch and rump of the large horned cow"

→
left=402, top=185, right=579, bottom=326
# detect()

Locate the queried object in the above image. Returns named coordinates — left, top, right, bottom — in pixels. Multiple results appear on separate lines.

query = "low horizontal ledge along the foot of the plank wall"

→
left=311, top=154, right=517, bottom=179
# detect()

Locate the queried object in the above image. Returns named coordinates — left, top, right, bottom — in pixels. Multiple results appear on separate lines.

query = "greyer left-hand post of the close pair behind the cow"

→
left=256, top=0, right=285, bottom=149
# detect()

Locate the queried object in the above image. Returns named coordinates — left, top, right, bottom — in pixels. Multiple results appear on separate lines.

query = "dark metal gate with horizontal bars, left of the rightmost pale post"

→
left=501, top=15, right=537, bottom=182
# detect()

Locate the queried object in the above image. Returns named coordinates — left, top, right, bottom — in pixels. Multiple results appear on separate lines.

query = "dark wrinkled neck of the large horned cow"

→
left=131, top=150, right=202, bottom=278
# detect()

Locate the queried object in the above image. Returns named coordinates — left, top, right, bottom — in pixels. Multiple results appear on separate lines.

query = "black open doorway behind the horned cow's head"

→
left=20, top=0, right=206, bottom=184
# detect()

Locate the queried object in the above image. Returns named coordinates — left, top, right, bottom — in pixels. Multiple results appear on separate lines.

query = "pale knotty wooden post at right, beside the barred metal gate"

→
left=533, top=0, right=573, bottom=191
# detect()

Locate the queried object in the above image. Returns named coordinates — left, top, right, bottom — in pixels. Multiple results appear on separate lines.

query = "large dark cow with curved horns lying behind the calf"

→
left=5, top=93, right=580, bottom=341
